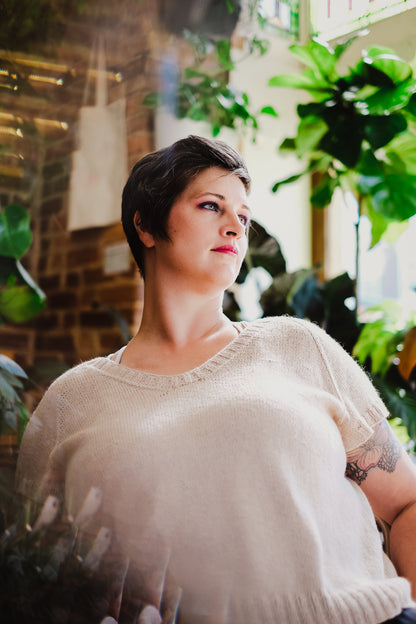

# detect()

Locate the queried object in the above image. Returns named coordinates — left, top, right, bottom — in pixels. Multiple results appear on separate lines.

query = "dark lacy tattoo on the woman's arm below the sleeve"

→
left=345, top=421, right=401, bottom=485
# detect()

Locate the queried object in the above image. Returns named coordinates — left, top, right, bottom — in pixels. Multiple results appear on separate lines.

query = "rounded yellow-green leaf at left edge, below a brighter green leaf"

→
left=0, top=285, right=45, bottom=323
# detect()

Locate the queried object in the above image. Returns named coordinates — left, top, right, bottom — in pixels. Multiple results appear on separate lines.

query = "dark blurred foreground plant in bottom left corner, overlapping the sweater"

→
left=0, top=470, right=181, bottom=624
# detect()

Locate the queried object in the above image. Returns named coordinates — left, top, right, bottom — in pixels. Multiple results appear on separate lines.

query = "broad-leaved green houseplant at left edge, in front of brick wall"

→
left=0, top=204, right=46, bottom=436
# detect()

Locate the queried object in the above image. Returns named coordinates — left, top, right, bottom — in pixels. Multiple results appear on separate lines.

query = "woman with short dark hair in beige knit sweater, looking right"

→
left=18, top=136, right=416, bottom=624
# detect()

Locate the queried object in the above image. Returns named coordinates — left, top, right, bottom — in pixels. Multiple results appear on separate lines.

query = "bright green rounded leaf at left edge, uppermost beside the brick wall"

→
left=0, top=204, right=32, bottom=260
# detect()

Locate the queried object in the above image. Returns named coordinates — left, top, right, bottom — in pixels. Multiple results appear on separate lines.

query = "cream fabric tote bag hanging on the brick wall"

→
left=68, top=39, right=127, bottom=230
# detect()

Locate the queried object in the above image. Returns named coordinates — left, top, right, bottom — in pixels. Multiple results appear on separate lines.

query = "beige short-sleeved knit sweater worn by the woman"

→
left=18, top=317, right=412, bottom=624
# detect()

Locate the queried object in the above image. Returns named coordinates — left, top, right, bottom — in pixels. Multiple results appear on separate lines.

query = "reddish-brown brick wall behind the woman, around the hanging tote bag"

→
left=0, top=0, right=162, bottom=400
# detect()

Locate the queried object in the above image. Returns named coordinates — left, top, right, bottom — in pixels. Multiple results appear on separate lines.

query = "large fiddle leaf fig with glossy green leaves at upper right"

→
left=269, top=35, right=416, bottom=244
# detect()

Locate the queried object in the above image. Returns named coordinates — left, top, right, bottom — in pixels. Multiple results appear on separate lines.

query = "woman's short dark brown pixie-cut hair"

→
left=121, top=135, right=251, bottom=277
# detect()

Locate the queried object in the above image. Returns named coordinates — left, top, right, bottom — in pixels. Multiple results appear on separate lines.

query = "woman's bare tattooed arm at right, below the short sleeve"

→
left=346, top=421, right=416, bottom=599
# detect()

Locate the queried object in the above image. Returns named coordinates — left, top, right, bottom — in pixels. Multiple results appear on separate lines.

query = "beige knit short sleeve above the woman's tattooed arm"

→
left=292, top=322, right=388, bottom=451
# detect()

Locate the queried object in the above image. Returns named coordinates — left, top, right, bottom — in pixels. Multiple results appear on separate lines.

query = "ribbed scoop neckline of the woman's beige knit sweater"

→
left=87, top=318, right=275, bottom=388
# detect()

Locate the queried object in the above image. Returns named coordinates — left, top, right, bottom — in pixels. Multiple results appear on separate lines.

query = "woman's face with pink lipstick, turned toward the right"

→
left=147, top=167, right=250, bottom=291
